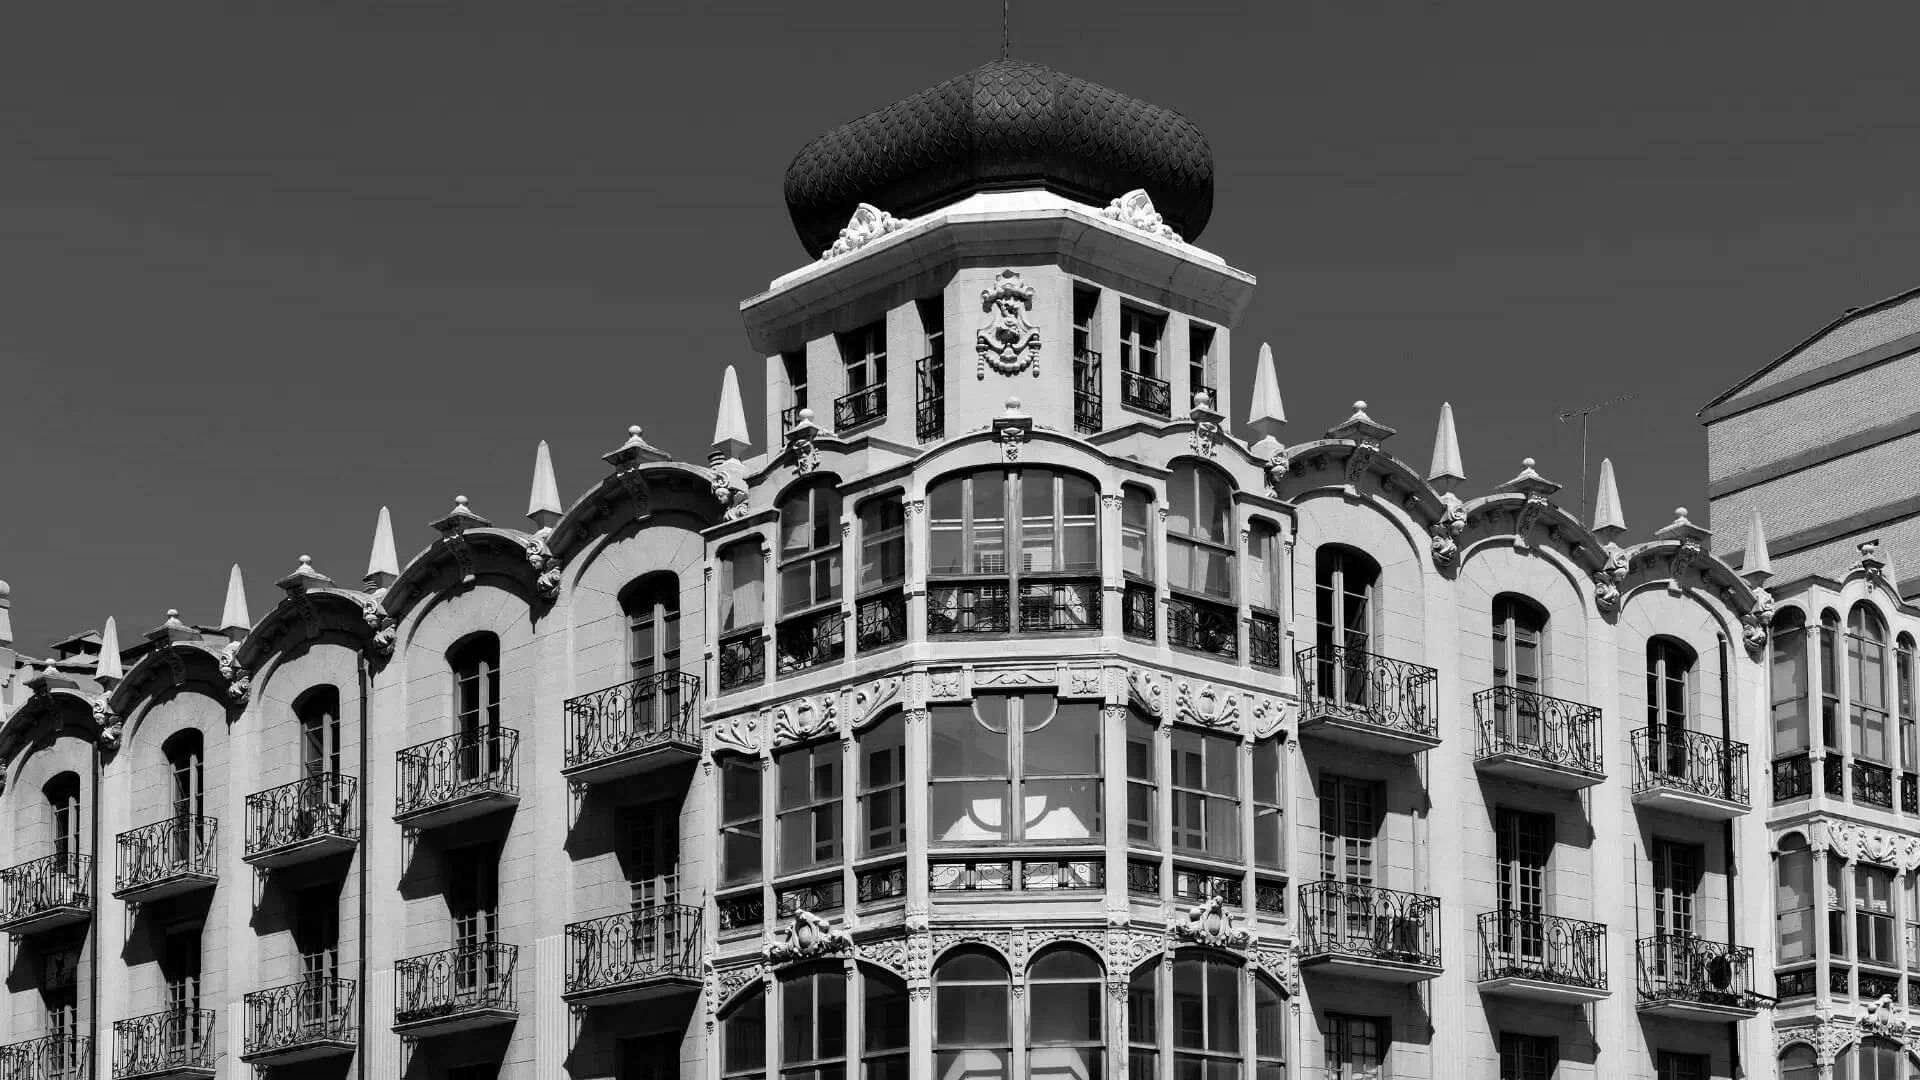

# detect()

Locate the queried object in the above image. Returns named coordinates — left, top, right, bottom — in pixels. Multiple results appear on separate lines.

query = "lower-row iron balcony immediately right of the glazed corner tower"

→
left=1300, top=880, right=1440, bottom=984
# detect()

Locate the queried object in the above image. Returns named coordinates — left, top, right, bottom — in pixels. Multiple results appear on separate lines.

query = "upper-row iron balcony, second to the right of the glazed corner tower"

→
left=1473, top=686, right=1607, bottom=790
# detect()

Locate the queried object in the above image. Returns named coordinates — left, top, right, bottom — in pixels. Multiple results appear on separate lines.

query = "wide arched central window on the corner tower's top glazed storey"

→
left=927, top=469, right=1100, bottom=634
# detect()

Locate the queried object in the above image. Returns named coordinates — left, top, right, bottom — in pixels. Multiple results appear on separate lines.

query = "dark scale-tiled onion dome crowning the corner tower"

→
left=785, top=60, right=1213, bottom=256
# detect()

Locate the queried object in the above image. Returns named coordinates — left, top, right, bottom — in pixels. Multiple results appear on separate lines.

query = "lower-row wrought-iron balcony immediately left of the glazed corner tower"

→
left=563, top=903, right=703, bottom=1005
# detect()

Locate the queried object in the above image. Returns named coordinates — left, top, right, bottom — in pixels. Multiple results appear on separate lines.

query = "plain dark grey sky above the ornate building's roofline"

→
left=0, top=0, right=1920, bottom=655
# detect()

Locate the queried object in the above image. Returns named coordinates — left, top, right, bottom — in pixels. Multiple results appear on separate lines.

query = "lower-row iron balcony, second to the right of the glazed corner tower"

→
left=1480, top=911, right=1607, bottom=1003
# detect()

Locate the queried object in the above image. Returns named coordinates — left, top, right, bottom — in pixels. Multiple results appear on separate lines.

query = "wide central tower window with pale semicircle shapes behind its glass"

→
left=929, top=694, right=1102, bottom=844
